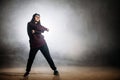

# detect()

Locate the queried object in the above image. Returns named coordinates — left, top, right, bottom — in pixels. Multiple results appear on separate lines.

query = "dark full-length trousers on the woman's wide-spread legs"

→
left=26, top=44, right=56, bottom=72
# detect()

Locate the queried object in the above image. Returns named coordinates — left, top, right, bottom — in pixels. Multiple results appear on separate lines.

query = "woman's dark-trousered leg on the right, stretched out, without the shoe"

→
left=40, top=44, right=56, bottom=70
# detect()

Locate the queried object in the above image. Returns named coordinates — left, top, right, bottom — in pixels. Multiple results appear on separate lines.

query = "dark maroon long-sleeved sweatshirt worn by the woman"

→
left=27, top=22, right=47, bottom=48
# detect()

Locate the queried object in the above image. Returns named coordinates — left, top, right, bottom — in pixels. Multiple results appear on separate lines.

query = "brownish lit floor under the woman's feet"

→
left=0, top=66, right=120, bottom=80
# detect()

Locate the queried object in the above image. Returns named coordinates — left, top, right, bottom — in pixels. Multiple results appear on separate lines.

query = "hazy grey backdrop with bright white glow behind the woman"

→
left=0, top=0, right=120, bottom=68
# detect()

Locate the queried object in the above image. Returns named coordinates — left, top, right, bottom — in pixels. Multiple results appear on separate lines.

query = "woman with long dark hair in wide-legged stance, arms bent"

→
left=24, top=13, right=59, bottom=77
